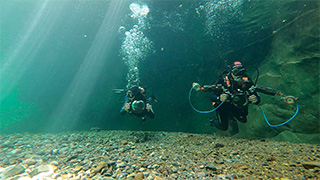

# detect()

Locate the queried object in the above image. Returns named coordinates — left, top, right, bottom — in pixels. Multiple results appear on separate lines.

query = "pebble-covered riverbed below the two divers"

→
left=0, top=129, right=320, bottom=180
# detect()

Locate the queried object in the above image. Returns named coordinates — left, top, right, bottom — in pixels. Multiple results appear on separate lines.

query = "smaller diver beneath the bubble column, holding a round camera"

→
left=120, top=86, right=157, bottom=122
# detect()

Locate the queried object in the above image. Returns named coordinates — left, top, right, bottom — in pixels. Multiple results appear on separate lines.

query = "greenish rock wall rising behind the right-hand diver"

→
left=240, top=10, right=320, bottom=143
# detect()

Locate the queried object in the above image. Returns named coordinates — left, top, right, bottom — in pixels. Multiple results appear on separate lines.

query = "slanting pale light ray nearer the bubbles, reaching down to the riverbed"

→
left=46, top=1, right=123, bottom=132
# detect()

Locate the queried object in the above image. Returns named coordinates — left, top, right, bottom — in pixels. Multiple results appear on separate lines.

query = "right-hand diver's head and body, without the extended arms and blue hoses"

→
left=210, top=61, right=260, bottom=134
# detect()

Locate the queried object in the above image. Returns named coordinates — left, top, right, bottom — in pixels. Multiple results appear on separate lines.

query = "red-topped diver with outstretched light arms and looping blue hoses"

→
left=189, top=61, right=299, bottom=135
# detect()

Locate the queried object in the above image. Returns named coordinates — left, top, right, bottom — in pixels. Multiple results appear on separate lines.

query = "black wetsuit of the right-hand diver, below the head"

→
left=210, top=74, right=260, bottom=133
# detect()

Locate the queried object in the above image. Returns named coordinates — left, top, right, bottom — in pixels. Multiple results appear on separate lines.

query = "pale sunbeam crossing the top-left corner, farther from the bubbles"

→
left=0, top=0, right=60, bottom=99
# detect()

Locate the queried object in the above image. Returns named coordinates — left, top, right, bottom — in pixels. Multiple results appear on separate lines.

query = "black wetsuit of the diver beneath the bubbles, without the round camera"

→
left=120, top=86, right=155, bottom=119
